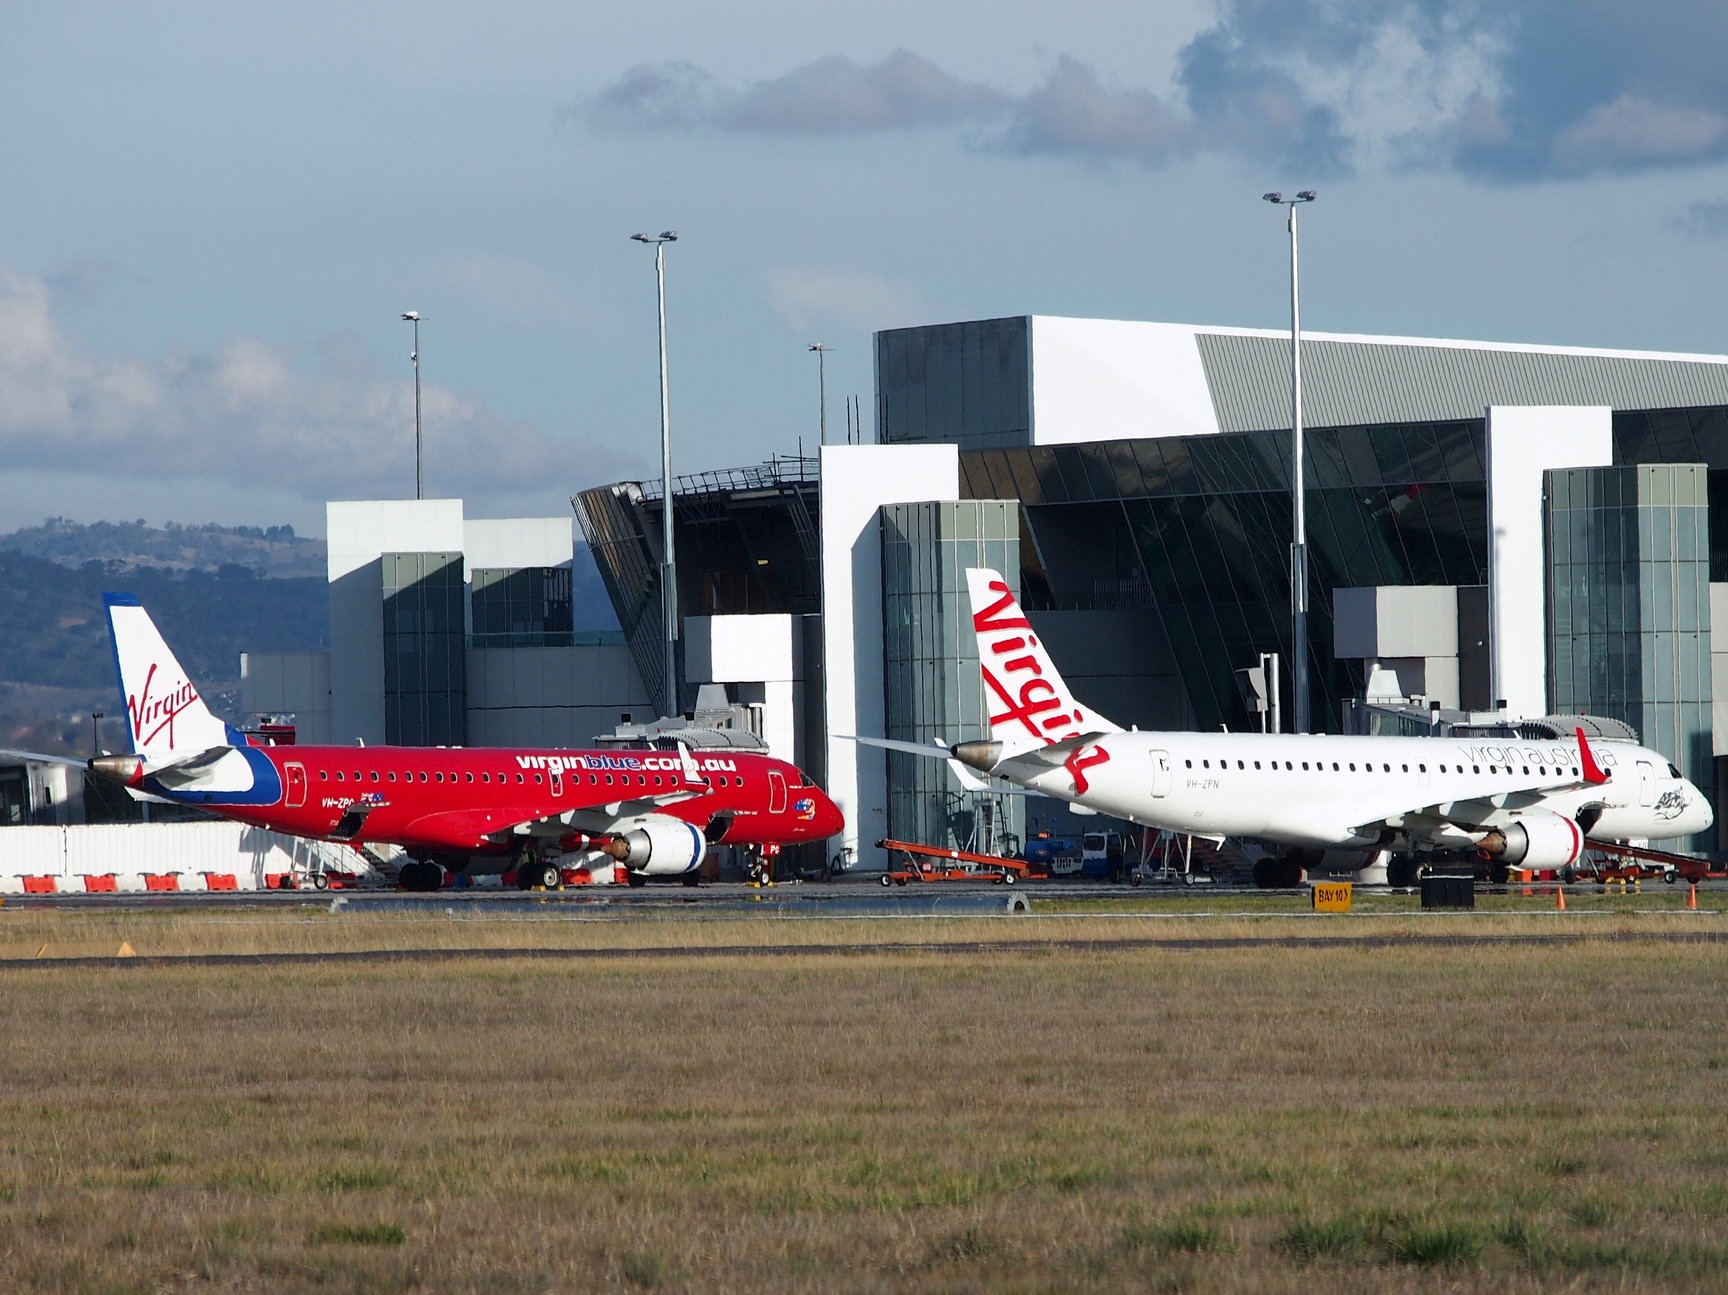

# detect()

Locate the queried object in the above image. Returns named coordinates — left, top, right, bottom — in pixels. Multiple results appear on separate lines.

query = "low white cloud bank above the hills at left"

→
left=0, top=268, right=636, bottom=515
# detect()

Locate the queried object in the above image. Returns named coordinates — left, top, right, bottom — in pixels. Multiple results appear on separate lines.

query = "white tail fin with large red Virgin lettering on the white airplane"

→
left=966, top=567, right=1121, bottom=759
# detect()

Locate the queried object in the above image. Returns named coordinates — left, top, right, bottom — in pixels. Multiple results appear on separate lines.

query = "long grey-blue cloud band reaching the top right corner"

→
left=584, top=0, right=1728, bottom=180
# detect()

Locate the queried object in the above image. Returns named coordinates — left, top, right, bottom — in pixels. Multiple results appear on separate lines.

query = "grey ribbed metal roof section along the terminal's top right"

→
left=1194, top=330, right=1728, bottom=432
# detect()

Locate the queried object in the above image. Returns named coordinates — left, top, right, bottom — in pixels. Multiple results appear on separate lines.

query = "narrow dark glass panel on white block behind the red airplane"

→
left=380, top=553, right=468, bottom=747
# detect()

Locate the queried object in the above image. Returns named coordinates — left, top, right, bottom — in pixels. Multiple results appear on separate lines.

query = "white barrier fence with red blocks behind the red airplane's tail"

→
left=0, top=823, right=366, bottom=894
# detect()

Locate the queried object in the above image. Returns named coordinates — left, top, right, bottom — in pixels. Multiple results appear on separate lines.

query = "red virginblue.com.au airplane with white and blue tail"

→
left=74, top=593, right=842, bottom=890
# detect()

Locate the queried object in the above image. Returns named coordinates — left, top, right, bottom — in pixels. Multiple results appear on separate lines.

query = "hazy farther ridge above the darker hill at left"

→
left=0, top=517, right=325, bottom=579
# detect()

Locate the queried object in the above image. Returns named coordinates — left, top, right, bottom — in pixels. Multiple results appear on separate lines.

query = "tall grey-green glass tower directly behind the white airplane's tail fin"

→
left=881, top=500, right=1025, bottom=852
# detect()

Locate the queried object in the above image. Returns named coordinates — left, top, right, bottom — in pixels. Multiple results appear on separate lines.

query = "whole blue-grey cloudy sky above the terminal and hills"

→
left=0, top=0, right=1728, bottom=533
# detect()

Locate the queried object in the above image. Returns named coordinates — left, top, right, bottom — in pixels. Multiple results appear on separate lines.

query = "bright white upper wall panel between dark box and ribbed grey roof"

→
left=1032, top=315, right=1218, bottom=444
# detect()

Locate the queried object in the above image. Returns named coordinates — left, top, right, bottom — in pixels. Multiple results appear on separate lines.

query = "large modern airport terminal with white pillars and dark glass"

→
left=245, top=307, right=1728, bottom=868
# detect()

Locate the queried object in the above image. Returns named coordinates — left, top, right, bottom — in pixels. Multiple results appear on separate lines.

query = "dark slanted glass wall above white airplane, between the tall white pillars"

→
left=961, top=418, right=1488, bottom=730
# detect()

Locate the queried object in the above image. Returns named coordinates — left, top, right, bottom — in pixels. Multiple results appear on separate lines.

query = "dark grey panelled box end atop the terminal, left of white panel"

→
left=876, top=315, right=1032, bottom=450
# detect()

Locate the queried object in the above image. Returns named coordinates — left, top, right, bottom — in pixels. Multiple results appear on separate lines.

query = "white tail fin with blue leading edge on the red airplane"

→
left=104, top=593, right=235, bottom=768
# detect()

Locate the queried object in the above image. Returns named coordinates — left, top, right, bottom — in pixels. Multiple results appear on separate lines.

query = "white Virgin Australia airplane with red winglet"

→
left=861, top=569, right=1714, bottom=887
